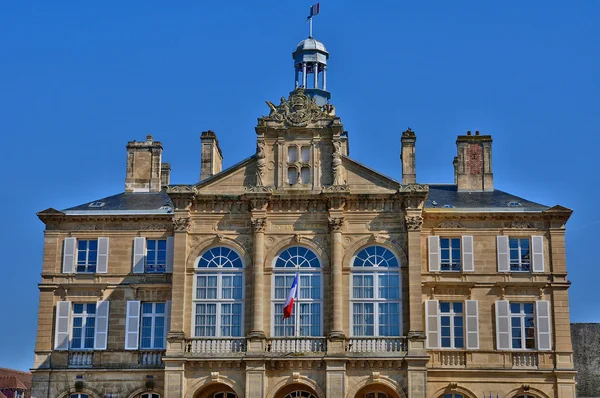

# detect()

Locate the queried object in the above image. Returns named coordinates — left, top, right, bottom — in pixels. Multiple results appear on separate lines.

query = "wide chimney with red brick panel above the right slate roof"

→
left=452, top=131, right=494, bottom=191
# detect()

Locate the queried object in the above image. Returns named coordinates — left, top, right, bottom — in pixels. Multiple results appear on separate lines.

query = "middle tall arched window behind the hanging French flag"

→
left=272, top=246, right=323, bottom=336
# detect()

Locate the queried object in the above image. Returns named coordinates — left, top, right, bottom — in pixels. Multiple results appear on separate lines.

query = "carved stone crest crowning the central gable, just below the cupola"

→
left=258, top=88, right=335, bottom=127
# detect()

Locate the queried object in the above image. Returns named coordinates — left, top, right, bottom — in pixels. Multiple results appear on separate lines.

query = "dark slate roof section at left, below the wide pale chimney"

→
left=63, top=191, right=174, bottom=215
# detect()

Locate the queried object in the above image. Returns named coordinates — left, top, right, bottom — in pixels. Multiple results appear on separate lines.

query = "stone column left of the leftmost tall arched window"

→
left=167, top=211, right=190, bottom=356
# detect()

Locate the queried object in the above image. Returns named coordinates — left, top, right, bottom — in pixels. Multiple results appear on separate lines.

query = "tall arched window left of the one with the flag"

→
left=193, top=246, right=244, bottom=337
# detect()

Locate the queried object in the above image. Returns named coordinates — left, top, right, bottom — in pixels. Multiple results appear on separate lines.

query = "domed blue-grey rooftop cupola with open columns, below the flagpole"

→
left=292, top=36, right=331, bottom=105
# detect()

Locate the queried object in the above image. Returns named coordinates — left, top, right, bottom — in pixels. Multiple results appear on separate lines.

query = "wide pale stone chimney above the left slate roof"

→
left=125, top=135, right=162, bottom=192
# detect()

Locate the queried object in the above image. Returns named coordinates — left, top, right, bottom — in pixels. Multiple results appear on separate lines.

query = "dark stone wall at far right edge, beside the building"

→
left=571, top=323, right=600, bottom=397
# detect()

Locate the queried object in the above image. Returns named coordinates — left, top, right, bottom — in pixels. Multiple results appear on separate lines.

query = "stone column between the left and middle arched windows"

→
left=249, top=217, right=267, bottom=339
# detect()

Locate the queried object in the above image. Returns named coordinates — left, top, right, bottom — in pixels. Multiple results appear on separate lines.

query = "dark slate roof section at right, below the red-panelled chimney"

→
left=425, top=184, right=549, bottom=212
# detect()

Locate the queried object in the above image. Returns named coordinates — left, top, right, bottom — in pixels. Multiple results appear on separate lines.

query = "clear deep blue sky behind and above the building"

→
left=0, top=0, right=600, bottom=369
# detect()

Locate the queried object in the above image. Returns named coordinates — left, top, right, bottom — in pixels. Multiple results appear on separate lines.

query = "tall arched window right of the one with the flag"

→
left=351, top=246, right=402, bottom=337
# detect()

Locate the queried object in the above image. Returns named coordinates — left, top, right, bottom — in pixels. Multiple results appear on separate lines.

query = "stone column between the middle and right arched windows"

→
left=329, top=217, right=344, bottom=338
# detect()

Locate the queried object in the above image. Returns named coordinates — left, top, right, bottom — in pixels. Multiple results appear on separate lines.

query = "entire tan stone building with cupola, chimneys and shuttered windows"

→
left=32, top=33, right=575, bottom=398
